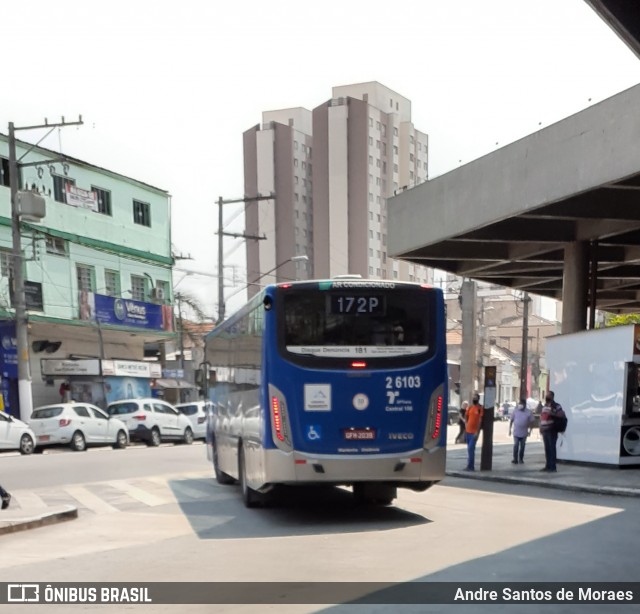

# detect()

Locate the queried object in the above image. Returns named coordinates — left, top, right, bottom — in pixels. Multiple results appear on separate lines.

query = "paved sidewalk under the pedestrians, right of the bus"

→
left=447, top=422, right=640, bottom=497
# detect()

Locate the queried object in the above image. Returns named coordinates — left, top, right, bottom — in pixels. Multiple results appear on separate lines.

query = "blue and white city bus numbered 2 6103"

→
left=206, top=277, right=448, bottom=507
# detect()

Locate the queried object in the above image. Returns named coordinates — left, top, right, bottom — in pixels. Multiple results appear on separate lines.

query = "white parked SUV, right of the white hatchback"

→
left=107, top=399, right=193, bottom=446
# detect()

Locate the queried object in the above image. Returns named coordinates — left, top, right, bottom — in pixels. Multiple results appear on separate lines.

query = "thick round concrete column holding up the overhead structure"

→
left=562, top=241, right=589, bottom=334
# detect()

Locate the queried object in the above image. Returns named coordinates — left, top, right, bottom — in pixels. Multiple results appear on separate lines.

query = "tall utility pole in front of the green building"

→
left=9, top=116, right=82, bottom=422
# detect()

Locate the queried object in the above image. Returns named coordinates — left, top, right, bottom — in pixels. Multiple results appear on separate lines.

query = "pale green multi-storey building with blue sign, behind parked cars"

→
left=0, top=134, right=175, bottom=415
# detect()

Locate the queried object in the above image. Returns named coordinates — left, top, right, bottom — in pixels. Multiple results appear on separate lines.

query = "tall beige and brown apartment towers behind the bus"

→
left=244, top=82, right=432, bottom=296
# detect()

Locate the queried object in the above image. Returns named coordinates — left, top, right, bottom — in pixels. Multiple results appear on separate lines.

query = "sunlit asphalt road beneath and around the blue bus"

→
left=0, top=445, right=640, bottom=613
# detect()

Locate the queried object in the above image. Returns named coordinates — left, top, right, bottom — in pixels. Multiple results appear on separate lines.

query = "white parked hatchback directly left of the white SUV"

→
left=29, top=402, right=129, bottom=452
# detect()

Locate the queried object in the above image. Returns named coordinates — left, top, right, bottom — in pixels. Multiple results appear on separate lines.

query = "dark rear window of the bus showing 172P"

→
left=281, top=288, right=433, bottom=358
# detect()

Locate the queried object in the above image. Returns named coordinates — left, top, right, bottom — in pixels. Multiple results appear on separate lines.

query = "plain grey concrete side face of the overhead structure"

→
left=388, top=85, right=640, bottom=257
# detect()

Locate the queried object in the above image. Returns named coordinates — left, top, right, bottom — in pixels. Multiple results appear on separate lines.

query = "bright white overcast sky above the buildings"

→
left=0, top=0, right=640, bottom=316
